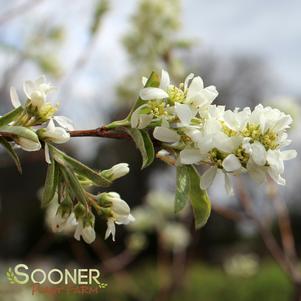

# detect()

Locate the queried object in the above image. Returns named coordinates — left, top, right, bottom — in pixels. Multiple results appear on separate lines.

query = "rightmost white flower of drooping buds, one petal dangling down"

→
left=105, top=192, right=135, bottom=241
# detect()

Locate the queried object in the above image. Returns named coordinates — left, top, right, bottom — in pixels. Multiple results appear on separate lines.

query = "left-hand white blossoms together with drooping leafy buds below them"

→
left=0, top=76, right=134, bottom=243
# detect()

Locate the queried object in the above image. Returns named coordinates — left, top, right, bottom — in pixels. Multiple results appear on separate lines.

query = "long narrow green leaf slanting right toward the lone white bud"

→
left=49, top=145, right=112, bottom=187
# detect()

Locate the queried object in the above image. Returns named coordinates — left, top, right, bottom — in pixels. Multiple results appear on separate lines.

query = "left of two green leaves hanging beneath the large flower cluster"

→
left=175, top=165, right=190, bottom=213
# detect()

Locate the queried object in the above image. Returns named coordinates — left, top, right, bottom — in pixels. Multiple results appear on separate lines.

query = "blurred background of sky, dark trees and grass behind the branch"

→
left=0, top=0, right=301, bottom=301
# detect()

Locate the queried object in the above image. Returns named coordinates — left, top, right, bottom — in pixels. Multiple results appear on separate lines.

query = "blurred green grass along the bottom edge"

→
left=63, top=262, right=292, bottom=301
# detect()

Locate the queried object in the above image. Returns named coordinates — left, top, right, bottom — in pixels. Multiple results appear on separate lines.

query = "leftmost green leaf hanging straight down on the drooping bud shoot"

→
left=42, top=160, right=60, bottom=208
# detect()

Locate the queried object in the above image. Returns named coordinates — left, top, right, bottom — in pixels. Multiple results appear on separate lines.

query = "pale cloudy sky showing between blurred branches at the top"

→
left=0, top=0, right=301, bottom=111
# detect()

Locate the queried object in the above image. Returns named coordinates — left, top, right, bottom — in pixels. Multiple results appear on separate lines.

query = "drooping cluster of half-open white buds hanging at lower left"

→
left=47, top=163, right=135, bottom=244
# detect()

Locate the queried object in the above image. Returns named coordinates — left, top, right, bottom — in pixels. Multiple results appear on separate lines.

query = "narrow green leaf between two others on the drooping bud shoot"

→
left=59, top=165, right=87, bottom=206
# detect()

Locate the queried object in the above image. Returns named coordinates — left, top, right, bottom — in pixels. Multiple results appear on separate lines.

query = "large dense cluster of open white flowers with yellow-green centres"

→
left=131, top=70, right=297, bottom=194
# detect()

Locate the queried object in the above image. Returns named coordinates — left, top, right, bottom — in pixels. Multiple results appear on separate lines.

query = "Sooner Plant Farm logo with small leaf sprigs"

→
left=6, top=264, right=107, bottom=295
